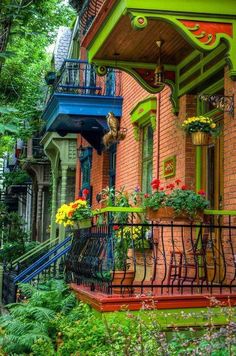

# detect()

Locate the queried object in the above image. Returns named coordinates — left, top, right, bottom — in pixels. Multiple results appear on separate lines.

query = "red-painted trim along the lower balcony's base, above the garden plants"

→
left=70, top=283, right=236, bottom=312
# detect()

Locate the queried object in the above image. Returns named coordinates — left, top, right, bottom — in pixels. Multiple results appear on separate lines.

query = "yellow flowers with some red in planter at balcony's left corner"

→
left=56, top=189, right=93, bottom=229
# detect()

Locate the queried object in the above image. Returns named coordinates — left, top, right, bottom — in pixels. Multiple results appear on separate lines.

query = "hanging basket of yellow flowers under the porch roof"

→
left=181, top=116, right=219, bottom=146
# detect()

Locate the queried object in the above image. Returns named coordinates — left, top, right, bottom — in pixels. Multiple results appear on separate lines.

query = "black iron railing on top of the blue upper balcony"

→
left=50, top=59, right=121, bottom=97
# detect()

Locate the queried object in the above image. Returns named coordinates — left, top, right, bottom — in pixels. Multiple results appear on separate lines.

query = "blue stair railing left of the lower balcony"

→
left=14, top=236, right=71, bottom=283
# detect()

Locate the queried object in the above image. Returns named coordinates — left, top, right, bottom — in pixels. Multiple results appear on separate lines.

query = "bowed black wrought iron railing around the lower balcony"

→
left=67, top=212, right=236, bottom=295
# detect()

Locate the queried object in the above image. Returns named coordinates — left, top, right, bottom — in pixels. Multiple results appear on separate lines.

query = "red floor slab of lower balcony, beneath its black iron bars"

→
left=70, top=283, right=236, bottom=312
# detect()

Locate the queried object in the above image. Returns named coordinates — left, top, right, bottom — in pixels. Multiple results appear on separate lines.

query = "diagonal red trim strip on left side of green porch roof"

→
left=81, top=0, right=119, bottom=48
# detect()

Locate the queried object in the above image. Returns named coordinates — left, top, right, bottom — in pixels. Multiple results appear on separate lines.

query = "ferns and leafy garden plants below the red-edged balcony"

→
left=0, top=280, right=236, bottom=356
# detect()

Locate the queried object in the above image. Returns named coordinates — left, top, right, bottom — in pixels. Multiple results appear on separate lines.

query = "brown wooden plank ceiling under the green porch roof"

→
left=94, top=15, right=193, bottom=65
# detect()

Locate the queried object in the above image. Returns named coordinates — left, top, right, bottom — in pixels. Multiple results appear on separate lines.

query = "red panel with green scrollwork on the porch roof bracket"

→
left=179, top=20, right=233, bottom=45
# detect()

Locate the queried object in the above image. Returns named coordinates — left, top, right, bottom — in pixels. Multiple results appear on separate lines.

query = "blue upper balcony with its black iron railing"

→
left=42, top=59, right=123, bottom=152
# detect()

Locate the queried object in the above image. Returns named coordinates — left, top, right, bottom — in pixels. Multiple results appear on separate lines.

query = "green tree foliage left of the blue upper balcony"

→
left=0, top=0, right=74, bottom=156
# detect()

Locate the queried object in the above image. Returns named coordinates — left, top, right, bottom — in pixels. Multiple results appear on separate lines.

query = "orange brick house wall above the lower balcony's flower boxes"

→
left=76, top=67, right=236, bottom=209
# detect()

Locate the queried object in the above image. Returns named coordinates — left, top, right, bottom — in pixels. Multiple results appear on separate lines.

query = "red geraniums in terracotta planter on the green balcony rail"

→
left=143, top=179, right=209, bottom=220
